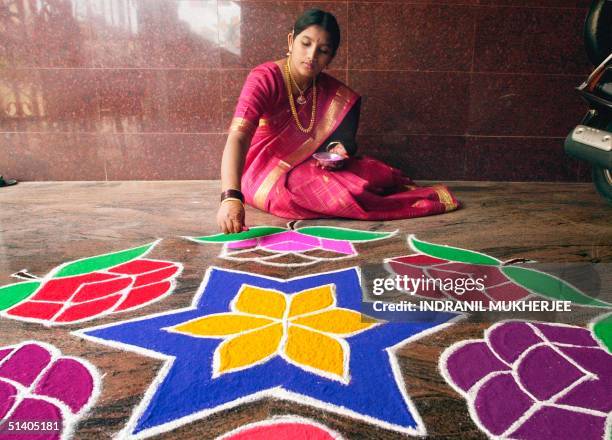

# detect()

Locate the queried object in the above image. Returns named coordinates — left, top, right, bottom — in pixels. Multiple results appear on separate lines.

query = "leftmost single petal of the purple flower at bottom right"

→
left=446, top=341, right=508, bottom=391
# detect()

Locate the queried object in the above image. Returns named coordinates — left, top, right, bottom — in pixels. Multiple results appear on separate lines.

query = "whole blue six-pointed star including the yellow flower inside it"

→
left=75, top=267, right=457, bottom=438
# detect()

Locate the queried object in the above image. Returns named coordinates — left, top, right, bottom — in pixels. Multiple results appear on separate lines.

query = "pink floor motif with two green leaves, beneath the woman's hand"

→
left=185, top=222, right=397, bottom=267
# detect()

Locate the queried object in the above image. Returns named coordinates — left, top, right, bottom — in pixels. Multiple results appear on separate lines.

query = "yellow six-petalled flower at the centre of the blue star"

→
left=169, top=284, right=377, bottom=383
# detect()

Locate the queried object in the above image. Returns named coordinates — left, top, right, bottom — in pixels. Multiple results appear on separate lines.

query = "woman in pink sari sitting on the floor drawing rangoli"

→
left=217, top=9, right=459, bottom=233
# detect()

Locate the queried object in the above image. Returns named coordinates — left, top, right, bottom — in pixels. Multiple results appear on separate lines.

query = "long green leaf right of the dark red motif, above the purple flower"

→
left=501, top=266, right=612, bottom=307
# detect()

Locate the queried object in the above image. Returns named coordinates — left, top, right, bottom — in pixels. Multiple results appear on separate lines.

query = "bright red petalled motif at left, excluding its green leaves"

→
left=4, top=259, right=181, bottom=324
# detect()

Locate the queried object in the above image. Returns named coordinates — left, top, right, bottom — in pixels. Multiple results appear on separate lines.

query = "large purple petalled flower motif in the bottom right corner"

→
left=440, top=321, right=612, bottom=440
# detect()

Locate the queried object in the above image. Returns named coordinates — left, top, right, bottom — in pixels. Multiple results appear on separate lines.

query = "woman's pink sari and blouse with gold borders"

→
left=230, top=62, right=459, bottom=220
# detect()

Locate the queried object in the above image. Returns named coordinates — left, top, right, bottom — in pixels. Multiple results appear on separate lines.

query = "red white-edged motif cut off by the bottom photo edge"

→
left=217, top=416, right=342, bottom=440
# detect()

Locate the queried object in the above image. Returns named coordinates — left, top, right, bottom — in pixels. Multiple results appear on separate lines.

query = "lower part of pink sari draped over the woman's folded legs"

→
left=270, top=157, right=459, bottom=220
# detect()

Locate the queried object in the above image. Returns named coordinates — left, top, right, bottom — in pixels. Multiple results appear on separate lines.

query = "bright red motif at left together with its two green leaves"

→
left=0, top=241, right=182, bottom=325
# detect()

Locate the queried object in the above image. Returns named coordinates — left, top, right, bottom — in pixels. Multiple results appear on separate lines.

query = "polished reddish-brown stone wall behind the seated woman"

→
left=0, top=0, right=591, bottom=181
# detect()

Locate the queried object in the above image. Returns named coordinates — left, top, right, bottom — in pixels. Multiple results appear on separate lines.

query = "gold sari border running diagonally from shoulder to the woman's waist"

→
left=253, top=86, right=353, bottom=211
